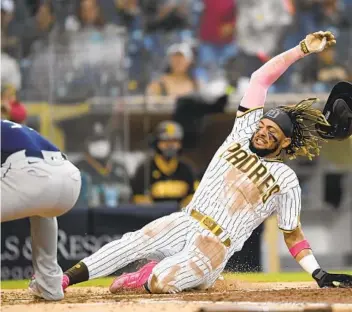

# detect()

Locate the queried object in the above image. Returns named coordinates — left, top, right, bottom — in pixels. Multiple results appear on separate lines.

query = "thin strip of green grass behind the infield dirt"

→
left=1, top=271, right=352, bottom=289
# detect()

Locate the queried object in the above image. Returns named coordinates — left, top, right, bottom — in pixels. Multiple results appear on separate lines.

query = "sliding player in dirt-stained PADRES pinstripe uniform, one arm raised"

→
left=63, top=32, right=352, bottom=293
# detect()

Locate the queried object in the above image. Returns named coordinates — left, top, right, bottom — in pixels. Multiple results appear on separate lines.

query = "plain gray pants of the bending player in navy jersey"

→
left=1, top=152, right=81, bottom=300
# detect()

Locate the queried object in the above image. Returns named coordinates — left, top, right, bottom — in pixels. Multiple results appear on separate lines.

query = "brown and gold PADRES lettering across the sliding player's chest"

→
left=220, top=143, right=280, bottom=203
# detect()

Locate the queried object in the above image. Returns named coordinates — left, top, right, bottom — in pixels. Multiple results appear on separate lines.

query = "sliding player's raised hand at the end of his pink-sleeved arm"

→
left=300, top=31, right=336, bottom=54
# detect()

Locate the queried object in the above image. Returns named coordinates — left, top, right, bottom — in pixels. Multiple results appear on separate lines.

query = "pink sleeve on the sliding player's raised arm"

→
left=241, top=46, right=304, bottom=109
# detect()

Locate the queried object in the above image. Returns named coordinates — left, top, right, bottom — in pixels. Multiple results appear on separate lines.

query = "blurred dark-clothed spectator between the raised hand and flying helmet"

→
left=301, top=48, right=349, bottom=92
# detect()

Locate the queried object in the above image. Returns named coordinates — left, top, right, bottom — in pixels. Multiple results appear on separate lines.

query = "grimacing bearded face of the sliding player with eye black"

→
left=251, top=119, right=291, bottom=157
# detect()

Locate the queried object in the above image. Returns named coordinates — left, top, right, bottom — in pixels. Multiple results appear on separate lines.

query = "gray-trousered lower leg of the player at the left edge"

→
left=29, top=217, right=64, bottom=300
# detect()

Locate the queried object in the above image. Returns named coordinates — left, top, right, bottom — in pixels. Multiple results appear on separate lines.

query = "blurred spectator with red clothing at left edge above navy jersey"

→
left=1, top=85, right=27, bottom=124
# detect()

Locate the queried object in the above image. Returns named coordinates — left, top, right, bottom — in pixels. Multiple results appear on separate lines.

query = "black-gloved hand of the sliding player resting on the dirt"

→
left=312, top=269, right=352, bottom=288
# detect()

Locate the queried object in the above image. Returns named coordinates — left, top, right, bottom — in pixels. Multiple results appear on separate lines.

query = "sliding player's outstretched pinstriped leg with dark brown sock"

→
left=63, top=212, right=191, bottom=287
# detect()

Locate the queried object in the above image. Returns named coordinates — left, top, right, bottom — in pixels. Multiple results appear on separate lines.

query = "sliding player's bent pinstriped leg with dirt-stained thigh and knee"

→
left=146, top=232, right=228, bottom=293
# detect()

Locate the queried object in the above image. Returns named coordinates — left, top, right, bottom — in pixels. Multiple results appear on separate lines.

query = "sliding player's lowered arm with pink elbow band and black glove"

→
left=277, top=184, right=352, bottom=287
